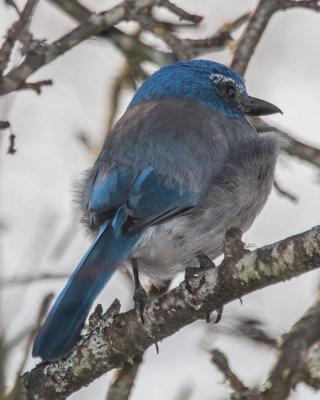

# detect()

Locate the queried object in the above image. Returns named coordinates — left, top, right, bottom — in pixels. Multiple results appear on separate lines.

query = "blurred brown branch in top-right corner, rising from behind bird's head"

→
left=231, top=0, right=320, bottom=75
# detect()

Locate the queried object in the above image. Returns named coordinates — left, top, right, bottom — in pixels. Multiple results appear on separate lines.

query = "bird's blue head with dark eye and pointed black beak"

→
left=128, top=60, right=281, bottom=119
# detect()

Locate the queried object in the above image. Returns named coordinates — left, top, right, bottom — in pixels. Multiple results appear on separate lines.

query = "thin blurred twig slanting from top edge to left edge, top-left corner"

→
left=0, top=0, right=39, bottom=76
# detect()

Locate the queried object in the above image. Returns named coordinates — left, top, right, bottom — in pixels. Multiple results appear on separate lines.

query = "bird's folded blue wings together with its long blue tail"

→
left=33, top=167, right=200, bottom=360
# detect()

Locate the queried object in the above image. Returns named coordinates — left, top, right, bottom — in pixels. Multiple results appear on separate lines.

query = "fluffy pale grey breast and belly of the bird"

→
left=132, top=133, right=285, bottom=283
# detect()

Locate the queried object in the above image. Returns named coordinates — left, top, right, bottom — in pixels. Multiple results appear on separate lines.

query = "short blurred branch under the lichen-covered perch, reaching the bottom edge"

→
left=106, top=355, right=142, bottom=400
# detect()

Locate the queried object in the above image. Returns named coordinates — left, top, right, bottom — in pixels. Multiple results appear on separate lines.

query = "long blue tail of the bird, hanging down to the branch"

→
left=32, top=207, right=140, bottom=360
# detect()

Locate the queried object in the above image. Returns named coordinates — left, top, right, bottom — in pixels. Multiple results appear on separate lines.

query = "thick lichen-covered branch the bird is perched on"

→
left=14, top=226, right=320, bottom=400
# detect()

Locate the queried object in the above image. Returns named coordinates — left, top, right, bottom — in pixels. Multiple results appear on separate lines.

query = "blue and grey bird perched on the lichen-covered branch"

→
left=33, top=59, right=284, bottom=361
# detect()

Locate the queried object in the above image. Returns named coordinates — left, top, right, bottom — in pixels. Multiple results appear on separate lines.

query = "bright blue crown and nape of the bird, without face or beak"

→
left=127, top=60, right=246, bottom=120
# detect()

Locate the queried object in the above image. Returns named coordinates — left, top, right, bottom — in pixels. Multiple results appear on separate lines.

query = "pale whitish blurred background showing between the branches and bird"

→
left=0, top=0, right=320, bottom=400
